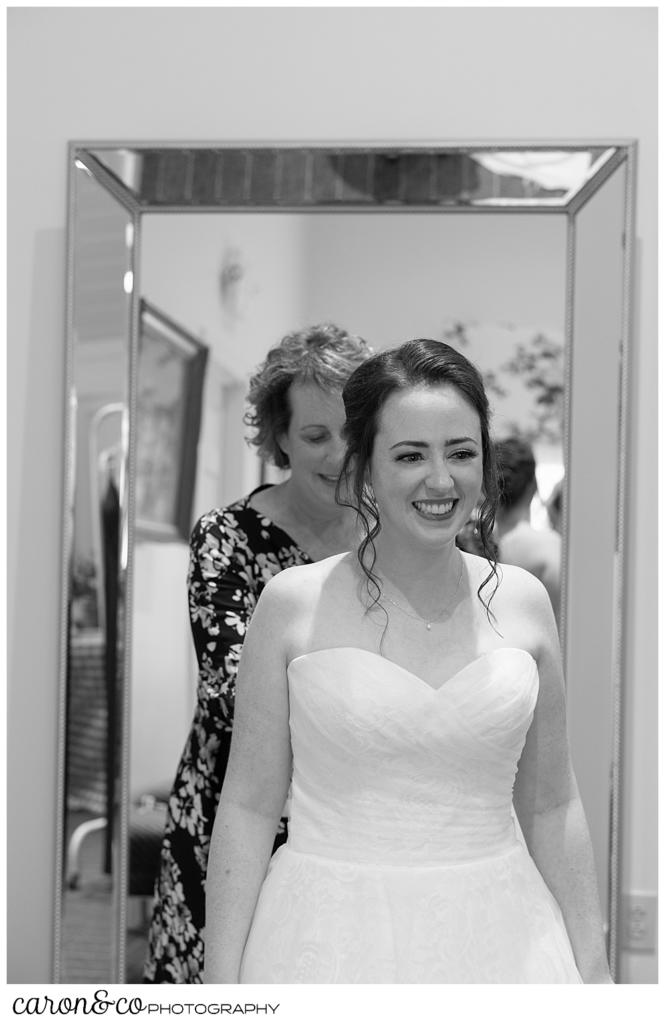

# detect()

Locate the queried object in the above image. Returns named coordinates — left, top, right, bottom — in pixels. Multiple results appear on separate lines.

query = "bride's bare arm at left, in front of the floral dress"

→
left=204, top=573, right=293, bottom=984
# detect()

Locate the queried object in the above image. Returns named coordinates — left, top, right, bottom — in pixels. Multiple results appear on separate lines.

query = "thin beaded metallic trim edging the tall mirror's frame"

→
left=52, top=139, right=637, bottom=983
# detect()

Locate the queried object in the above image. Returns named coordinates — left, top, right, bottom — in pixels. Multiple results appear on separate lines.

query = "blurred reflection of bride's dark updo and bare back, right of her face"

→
left=495, top=436, right=562, bottom=622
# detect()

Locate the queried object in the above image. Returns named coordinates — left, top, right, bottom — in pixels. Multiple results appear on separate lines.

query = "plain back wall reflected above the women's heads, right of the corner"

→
left=305, top=212, right=566, bottom=346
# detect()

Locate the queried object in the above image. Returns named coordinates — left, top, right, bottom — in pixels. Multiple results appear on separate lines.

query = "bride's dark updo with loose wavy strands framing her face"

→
left=337, top=338, right=499, bottom=621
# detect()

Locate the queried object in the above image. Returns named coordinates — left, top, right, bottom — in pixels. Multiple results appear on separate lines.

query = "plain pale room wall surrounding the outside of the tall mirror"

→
left=7, top=7, right=657, bottom=982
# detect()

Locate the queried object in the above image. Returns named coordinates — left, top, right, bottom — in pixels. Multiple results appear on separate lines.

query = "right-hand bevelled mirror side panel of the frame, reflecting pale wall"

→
left=566, top=162, right=627, bottom=977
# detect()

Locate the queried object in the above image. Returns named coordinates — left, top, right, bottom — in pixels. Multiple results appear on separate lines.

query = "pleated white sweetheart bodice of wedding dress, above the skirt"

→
left=288, top=647, right=538, bottom=865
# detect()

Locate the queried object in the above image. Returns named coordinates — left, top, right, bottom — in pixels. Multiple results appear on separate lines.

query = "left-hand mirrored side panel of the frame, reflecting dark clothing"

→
left=60, top=165, right=133, bottom=982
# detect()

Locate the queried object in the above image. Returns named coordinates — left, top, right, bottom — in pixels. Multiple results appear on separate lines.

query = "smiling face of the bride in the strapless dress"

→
left=370, top=384, right=483, bottom=548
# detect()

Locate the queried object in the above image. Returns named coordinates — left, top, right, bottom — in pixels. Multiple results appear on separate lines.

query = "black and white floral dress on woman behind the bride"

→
left=143, top=488, right=311, bottom=984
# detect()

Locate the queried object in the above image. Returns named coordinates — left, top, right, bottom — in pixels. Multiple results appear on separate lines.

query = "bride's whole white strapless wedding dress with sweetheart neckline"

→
left=241, top=647, right=581, bottom=984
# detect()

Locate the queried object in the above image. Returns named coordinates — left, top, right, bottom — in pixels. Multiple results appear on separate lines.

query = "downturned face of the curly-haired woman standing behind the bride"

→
left=278, top=384, right=345, bottom=506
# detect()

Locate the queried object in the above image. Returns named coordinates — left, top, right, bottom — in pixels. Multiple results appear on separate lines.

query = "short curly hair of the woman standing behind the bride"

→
left=244, top=324, right=372, bottom=469
